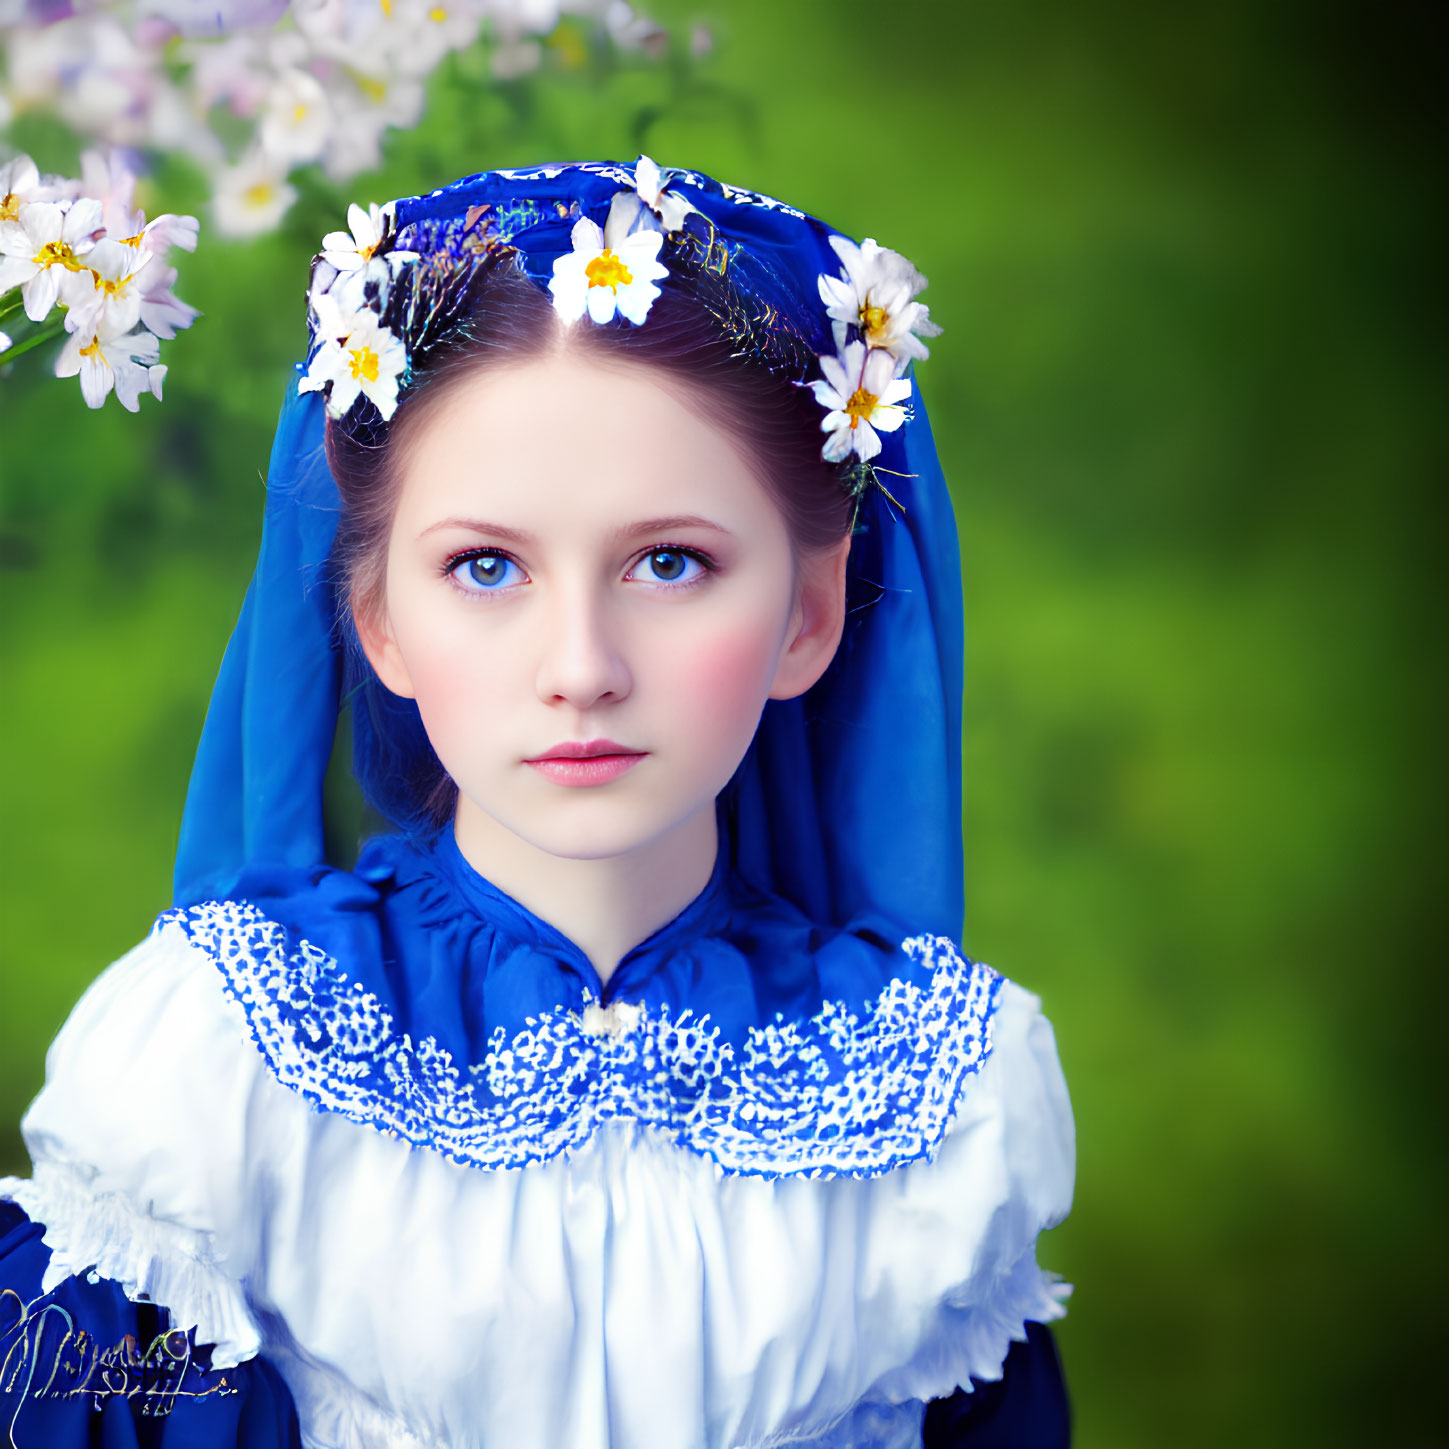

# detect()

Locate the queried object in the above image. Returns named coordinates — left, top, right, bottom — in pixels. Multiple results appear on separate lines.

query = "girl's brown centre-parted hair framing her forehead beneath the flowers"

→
left=326, top=258, right=852, bottom=628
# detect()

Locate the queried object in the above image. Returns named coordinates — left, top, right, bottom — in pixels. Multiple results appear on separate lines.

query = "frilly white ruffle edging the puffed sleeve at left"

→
left=0, top=1162, right=261, bottom=1369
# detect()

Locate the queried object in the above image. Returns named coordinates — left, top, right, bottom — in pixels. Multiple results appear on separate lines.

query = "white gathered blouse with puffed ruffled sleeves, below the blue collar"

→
left=0, top=922, right=1075, bottom=1449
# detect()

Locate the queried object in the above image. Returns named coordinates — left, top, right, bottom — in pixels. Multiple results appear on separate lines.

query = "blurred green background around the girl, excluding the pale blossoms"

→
left=0, top=0, right=1446, bottom=1449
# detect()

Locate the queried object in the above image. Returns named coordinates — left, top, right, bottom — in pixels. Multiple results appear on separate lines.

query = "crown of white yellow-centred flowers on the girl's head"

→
left=297, top=156, right=940, bottom=497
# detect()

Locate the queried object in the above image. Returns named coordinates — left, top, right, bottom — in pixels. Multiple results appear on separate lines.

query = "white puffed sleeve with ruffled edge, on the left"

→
left=0, top=923, right=279, bottom=1369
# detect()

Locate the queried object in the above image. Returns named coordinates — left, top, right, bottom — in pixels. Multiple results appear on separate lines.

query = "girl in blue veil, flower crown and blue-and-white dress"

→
left=0, top=158, right=1074, bottom=1449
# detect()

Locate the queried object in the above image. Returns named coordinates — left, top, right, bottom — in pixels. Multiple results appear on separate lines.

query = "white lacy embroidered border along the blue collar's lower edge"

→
left=156, top=901, right=1001, bottom=1177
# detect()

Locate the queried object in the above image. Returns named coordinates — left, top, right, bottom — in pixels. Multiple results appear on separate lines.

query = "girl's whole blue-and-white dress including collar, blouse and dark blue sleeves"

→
left=0, top=830, right=1071, bottom=1449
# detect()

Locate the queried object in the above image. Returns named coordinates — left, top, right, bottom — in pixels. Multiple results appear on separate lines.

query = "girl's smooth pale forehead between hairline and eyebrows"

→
left=398, top=351, right=784, bottom=530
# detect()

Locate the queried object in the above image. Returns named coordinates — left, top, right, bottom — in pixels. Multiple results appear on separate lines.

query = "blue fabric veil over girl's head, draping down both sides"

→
left=175, top=164, right=962, bottom=939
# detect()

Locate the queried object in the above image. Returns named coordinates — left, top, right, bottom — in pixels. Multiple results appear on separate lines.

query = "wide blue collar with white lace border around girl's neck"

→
left=158, top=832, right=1001, bottom=1177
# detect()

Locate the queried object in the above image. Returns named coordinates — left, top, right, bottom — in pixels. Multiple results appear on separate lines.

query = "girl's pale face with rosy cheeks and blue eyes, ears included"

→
left=358, top=352, right=848, bottom=859
